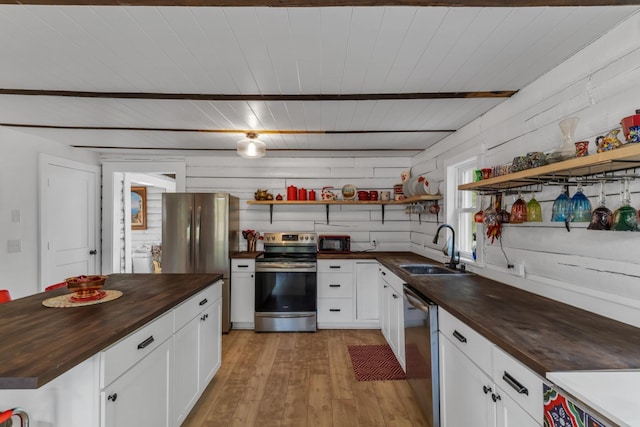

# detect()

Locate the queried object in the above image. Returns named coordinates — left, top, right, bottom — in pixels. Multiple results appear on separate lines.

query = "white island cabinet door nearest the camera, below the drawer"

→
left=100, top=340, right=173, bottom=427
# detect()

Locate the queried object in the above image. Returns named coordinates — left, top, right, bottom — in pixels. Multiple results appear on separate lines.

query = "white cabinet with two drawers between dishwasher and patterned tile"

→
left=439, top=308, right=543, bottom=427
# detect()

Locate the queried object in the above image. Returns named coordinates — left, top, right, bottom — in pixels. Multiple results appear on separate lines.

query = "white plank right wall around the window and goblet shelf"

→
left=411, top=15, right=640, bottom=326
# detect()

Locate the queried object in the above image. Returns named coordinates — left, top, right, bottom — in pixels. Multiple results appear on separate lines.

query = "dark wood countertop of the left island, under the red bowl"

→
left=0, top=274, right=222, bottom=389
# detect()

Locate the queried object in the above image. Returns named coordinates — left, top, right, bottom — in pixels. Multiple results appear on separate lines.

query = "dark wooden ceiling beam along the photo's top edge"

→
left=0, top=0, right=638, bottom=7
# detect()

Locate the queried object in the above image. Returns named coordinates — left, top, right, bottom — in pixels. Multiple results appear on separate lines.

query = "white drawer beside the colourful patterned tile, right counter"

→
left=493, top=346, right=544, bottom=420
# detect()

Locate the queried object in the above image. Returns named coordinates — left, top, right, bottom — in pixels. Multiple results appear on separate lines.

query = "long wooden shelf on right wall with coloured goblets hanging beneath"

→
left=458, top=144, right=640, bottom=192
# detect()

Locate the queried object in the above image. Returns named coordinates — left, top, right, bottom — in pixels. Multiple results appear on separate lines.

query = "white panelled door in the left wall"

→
left=40, top=156, right=99, bottom=289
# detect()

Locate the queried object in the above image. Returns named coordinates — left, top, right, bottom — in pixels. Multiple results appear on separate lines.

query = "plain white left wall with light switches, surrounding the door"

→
left=0, top=126, right=99, bottom=298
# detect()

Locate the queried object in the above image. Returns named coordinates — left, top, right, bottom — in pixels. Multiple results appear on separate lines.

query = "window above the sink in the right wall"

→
left=447, top=158, right=478, bottom=261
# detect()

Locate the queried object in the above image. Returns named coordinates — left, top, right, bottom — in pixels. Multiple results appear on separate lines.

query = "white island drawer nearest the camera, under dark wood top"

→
left=100, top=311, right=173, bottom=388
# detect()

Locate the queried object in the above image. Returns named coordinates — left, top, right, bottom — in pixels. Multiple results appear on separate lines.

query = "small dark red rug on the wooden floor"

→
left=348, top=344, right=405, bottom=381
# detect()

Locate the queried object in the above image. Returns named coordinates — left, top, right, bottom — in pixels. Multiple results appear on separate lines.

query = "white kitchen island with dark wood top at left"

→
left=0, top=274, right=222, bottom=426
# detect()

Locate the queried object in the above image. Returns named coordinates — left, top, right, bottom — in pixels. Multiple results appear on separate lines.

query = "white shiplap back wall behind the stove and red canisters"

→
left=186, top=156, right=411, bottom=251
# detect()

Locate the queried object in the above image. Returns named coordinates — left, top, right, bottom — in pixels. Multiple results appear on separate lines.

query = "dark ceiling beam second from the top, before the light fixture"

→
left=0, top=88, right=517, bottom=102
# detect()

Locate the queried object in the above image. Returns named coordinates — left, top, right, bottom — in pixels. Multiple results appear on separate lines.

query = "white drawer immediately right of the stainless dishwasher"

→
left=438, top=308, right=493, bottom=375
